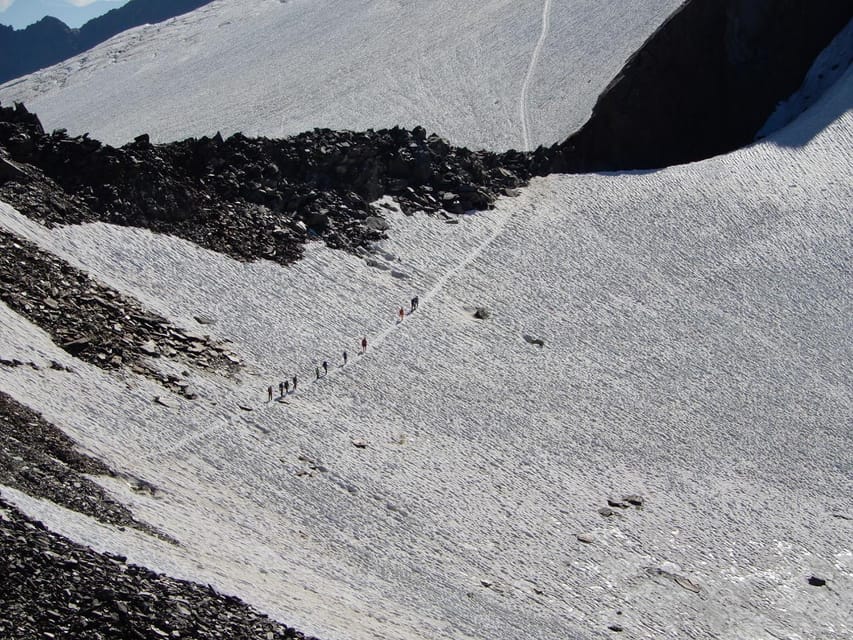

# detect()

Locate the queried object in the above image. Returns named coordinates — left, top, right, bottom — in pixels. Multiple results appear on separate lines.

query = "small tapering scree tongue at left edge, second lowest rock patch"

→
left=0, top=391, right=172, bottom=541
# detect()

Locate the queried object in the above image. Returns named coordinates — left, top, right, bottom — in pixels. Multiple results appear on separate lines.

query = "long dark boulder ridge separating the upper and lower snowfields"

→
left=0, top=104, right=547, bottom=264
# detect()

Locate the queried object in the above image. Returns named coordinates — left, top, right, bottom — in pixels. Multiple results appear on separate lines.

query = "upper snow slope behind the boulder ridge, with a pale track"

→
left=0, top=0, right=680, bottom=150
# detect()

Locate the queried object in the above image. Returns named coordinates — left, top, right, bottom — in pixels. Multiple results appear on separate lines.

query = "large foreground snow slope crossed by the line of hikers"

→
left=0, top=58, right=853, bottom=640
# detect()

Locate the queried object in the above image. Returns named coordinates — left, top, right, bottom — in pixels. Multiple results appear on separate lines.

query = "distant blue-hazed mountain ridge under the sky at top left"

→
left=0, top=0, right=210, bottom=82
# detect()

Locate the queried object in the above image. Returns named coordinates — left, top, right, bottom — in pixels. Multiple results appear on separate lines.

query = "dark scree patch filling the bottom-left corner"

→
left=0, top=498, right=315, bottom=640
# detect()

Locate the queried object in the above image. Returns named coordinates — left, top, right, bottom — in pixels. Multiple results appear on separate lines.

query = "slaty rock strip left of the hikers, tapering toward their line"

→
left=0, top=229, right=240, bottom=399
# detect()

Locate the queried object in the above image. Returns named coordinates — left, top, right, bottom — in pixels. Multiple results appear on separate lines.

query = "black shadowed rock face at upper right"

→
left=554, top=0, right=853, bottom=172
